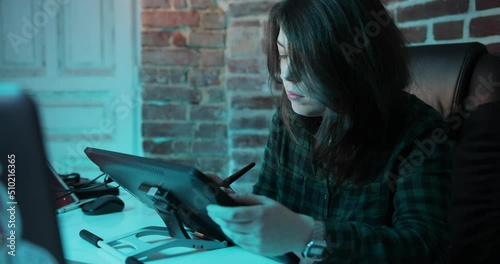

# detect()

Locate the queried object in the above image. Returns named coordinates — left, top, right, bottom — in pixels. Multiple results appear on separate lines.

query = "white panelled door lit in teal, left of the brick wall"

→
left=0, top=0, right=142, bottom=177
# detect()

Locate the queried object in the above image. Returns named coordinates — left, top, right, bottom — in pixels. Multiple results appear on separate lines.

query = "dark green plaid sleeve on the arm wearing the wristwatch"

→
left=324, top=124, right=451, bottom=264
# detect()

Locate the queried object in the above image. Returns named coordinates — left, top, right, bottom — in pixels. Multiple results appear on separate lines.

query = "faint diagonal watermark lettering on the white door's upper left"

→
left=7, top=0, right=70, bottom=54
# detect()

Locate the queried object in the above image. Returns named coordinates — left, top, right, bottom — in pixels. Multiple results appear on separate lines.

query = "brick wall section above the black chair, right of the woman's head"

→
left=385, top=0, right=500, bottom=52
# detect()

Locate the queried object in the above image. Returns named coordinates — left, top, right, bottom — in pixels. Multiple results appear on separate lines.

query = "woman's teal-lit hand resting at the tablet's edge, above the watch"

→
left=207, top=194, right=314, bottom=256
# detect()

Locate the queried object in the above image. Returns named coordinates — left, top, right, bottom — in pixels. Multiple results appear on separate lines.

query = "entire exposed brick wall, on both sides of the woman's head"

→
left=141, top=0, right=500, bottom=194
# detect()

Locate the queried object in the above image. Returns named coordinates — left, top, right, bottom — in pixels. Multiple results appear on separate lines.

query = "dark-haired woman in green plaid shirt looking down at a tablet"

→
left=207, top=0, right=451, bottom=263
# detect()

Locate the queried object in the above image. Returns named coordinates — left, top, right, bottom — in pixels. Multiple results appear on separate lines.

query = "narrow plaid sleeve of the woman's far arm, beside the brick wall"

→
left=253, top=109, right=283, bottom=200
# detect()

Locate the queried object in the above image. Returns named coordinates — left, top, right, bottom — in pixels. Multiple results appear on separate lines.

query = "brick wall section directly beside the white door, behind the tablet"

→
left=140, top=0, right=229, bottom=179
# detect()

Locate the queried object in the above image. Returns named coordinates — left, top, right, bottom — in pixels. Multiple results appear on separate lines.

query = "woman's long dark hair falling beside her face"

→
left=266, top=0, right=410, bottom=182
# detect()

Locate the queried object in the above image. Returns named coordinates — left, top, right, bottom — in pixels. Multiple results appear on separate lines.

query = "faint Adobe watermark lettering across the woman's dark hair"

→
left=340, top=9, right=392, bottom=63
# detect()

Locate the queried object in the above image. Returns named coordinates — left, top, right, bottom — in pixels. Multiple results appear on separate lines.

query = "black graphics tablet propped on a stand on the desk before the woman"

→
left=85, top=147, right=238, bottom=241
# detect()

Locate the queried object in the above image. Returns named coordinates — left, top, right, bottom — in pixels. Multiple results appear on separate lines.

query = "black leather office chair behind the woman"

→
left=408, top=42, right=500, bottom=263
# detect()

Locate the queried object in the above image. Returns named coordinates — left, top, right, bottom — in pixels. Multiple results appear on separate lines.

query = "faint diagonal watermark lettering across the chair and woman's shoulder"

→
left=384, top=73, right=500, bottom=192
